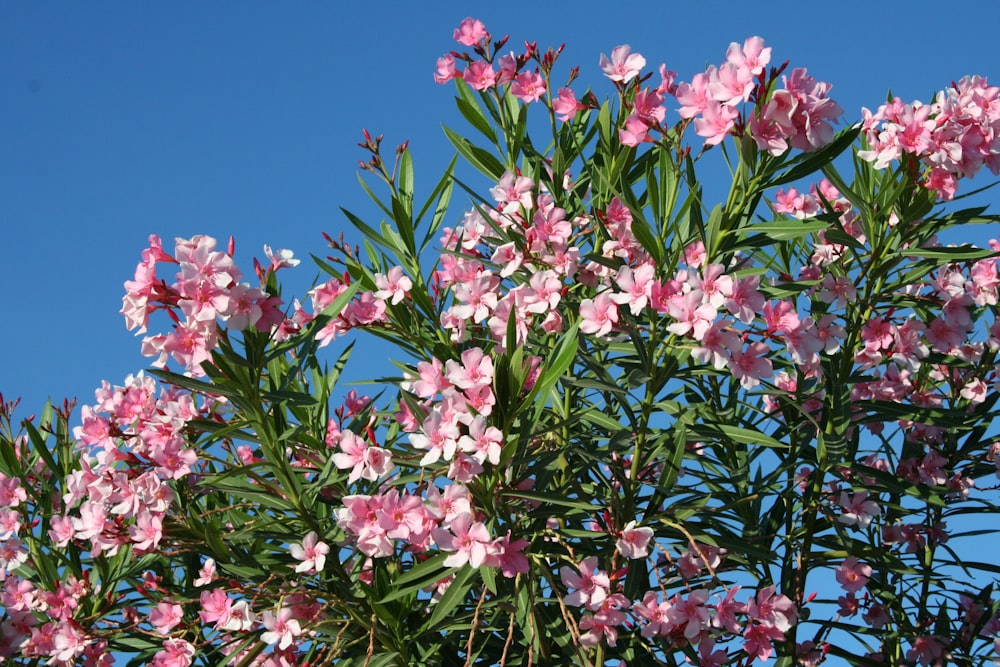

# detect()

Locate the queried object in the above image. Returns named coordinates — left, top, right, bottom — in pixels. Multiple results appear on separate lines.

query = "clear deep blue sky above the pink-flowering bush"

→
left=0, top=0, right=1000, bottom=416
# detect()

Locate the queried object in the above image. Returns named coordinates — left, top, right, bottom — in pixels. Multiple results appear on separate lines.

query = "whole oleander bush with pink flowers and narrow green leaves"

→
left=0, top=19, right=1000, bottom=667
